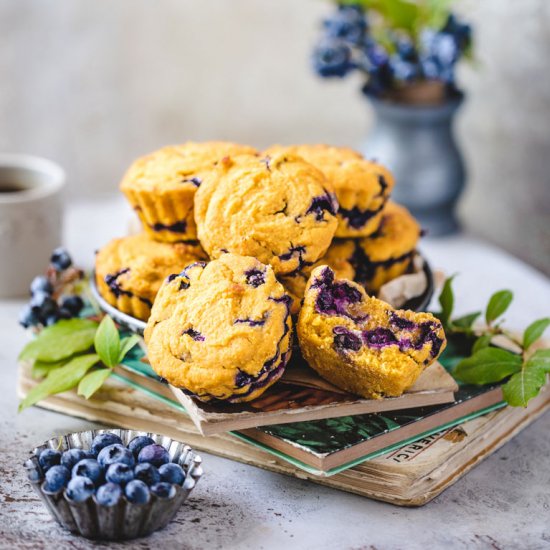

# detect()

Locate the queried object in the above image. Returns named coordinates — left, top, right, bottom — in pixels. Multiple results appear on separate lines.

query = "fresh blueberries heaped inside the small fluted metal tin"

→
left=37, top=433, right=185, bottom=506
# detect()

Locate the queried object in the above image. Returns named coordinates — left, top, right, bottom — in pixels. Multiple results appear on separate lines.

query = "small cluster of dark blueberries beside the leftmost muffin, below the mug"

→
left=19, top=248, right=84, bottom=328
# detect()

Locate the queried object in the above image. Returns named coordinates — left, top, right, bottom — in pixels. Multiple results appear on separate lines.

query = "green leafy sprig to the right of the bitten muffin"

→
left=436, top=275, right=550, bottom=407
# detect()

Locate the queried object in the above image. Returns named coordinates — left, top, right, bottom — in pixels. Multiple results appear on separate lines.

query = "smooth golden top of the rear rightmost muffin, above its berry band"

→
left=357, top=201, right=421, bottom=262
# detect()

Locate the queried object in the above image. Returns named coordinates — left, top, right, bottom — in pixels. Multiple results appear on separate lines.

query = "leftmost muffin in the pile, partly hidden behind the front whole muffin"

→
left=95, top=233, right=207, bottom=320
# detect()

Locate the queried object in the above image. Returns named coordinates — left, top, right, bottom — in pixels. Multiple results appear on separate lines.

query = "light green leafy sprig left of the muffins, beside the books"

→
left=19, top=316, right=139, bottom=411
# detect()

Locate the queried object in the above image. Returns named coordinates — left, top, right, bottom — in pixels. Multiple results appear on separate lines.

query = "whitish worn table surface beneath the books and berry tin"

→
left=0, top=198, right=550, bottom=550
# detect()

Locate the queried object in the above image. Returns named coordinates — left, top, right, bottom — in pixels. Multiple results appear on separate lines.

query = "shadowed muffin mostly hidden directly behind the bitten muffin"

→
left=279, top=239, right=355, bottom=315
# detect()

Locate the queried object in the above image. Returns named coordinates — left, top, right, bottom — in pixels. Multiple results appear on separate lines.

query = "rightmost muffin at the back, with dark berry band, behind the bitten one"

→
left=352, top=201, right=421, bottom=294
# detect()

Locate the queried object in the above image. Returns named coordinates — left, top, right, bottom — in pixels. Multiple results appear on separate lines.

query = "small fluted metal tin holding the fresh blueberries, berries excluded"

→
left=25, top=428, right=203, bottom=540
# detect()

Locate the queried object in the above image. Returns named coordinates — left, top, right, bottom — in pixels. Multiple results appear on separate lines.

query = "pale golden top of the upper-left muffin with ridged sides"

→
left=120, top=141, right=256, bottom=194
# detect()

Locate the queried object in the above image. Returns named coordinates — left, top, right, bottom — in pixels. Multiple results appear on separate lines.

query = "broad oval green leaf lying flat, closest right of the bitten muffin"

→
left=453, top=348, right=522, bottom=384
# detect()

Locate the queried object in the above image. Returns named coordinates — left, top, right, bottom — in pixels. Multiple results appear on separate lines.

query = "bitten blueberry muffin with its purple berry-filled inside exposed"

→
left=297, top=266, right=446, bottom=399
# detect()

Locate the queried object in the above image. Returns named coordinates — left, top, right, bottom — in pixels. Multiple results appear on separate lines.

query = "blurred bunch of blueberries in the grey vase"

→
left=313, top=5, right=472, bottom=95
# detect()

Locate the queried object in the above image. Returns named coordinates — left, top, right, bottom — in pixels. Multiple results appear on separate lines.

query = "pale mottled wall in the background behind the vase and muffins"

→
left=0, top=0, right=550, bottom=272
